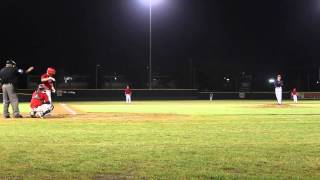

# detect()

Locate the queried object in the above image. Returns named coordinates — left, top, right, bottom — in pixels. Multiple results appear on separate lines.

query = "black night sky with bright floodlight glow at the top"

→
left=0, top=0, right=320, bottom=90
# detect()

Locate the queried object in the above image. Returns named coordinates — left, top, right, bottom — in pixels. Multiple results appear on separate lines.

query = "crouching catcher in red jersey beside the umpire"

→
left=30, top=84, right=53, bottom=118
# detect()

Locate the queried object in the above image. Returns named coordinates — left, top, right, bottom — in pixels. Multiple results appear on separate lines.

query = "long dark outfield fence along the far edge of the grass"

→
left=1, top=89, right=320, bottom=102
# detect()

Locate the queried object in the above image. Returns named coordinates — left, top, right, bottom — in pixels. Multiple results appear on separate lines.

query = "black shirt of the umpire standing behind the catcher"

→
left=0, top=67, right=19, bottom=85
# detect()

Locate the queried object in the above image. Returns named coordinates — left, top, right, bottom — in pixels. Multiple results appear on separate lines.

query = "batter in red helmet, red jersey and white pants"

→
left=41, top=67, right=56, bottom=104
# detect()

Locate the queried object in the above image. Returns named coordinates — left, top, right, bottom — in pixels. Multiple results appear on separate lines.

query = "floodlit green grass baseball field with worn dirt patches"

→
left=0, top=101, right=320, bottom=180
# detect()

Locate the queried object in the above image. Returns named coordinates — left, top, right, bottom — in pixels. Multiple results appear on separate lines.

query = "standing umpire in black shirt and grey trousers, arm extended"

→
left=0, top=60, right=34, bottom=118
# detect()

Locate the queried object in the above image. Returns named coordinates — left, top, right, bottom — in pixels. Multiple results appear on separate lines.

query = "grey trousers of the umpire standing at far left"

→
left=2, top=84, right=20, bottom=117
